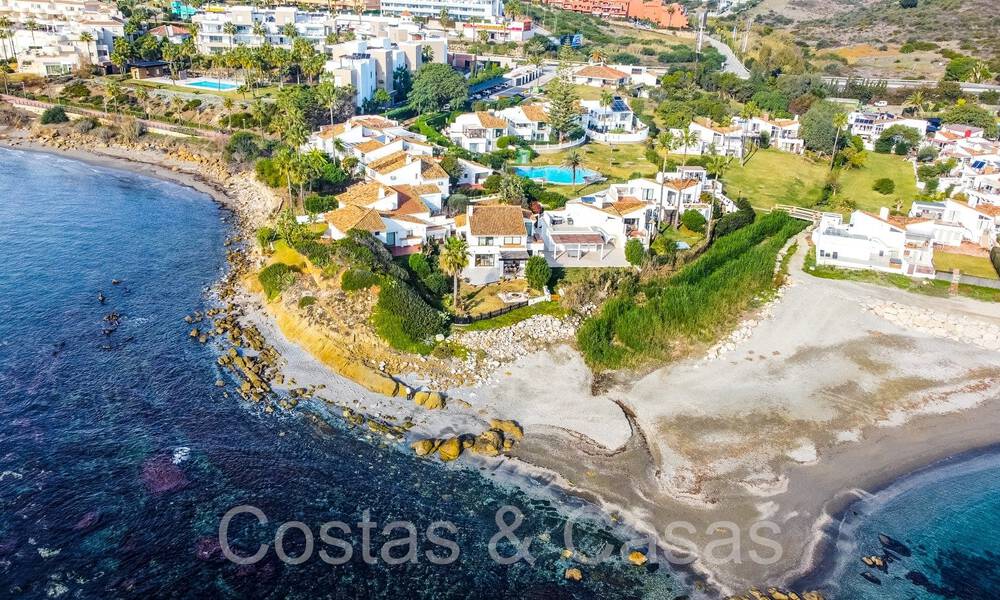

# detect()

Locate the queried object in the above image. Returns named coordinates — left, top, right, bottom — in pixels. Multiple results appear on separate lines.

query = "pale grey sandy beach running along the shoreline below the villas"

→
left=0, top=125, right=1000, bottom=592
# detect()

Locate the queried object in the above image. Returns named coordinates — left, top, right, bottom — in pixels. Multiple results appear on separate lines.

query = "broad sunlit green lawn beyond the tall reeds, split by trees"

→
left=723, top=150, right=917, bottom=212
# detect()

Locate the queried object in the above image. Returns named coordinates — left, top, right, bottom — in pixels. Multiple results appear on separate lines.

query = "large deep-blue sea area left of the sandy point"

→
left=0, top=149, right=694, bottom=600
